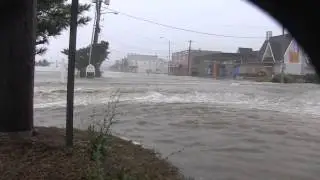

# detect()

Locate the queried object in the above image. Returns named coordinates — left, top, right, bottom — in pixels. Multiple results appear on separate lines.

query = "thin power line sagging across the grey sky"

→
left=108, top=8, right=265, bottom=39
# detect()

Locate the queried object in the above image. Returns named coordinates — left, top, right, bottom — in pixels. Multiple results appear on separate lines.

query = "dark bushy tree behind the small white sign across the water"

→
left=62, top=41, right=109, bottom=77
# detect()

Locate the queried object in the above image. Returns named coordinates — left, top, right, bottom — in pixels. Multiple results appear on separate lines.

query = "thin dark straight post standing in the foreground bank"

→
left=66, top=0, right=79, bottom=147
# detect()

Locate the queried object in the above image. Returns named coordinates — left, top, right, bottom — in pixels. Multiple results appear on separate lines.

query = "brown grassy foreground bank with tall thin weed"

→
left=0, top=93, right=188, bottom=180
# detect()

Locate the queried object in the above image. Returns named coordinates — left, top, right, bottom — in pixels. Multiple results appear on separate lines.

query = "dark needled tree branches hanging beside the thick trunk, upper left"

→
left=36, top=0, right=90, bottom=54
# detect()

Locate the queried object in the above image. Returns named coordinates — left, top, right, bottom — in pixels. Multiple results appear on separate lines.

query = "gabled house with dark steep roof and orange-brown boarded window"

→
left=258, top=31, right=315, bottom=75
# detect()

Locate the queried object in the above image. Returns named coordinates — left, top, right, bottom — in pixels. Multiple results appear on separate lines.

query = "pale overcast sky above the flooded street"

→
left=37, top=0, right=282, bottom=65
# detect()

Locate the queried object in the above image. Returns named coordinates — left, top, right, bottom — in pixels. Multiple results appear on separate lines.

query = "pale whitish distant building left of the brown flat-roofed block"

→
left=127, top=54, right=158, bottom=73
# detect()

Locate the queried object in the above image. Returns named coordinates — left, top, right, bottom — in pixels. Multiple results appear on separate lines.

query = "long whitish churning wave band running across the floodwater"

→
left=35, top=88, right=320, bottom=115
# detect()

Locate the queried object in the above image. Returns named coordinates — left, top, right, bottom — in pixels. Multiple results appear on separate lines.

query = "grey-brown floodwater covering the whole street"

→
left=34, top=68, right=320, bottom=180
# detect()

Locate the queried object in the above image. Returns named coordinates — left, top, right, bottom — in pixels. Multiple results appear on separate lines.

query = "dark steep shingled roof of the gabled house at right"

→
left=259, top=34, right=293, bottom=62
